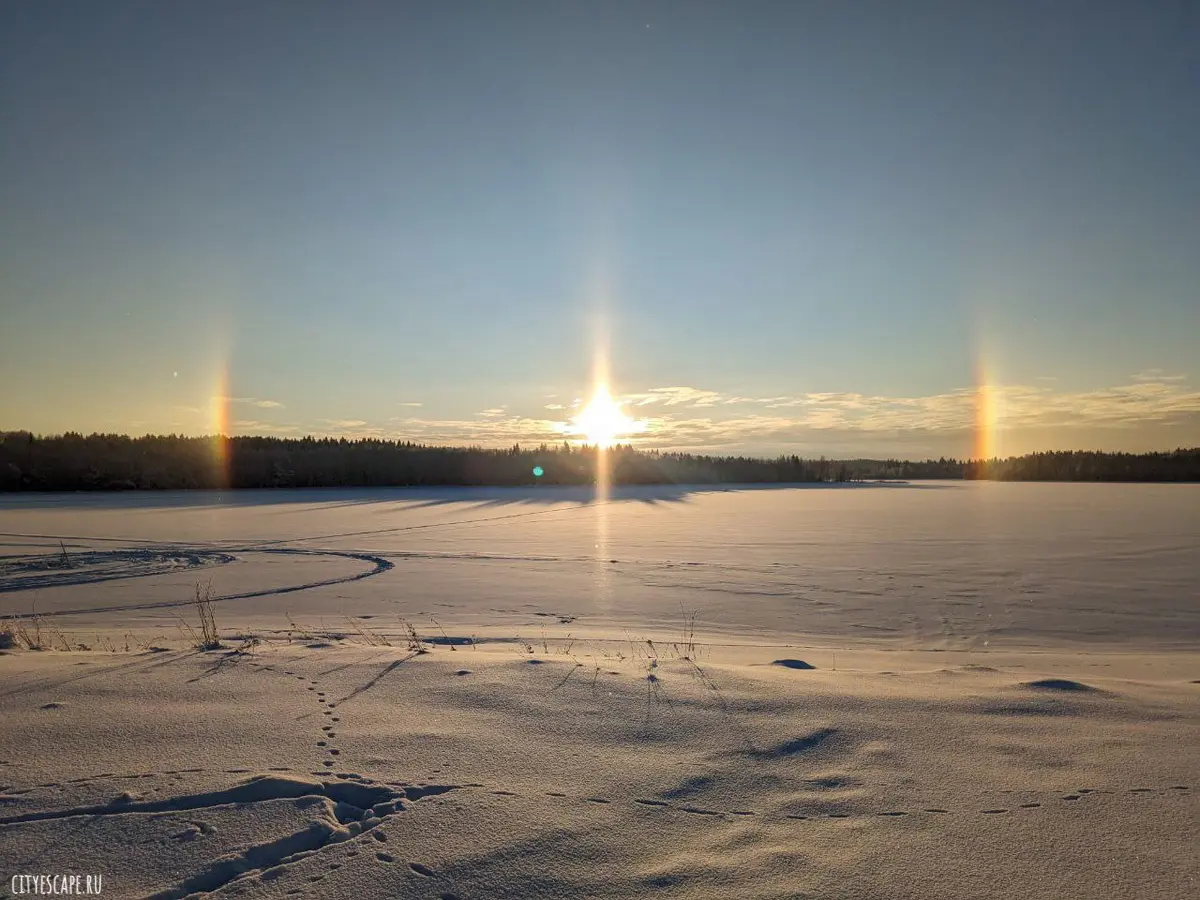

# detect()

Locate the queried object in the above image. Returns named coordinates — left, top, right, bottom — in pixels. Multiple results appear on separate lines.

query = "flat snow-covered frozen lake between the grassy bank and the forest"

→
left=0, top=482, right=1200, bottom=650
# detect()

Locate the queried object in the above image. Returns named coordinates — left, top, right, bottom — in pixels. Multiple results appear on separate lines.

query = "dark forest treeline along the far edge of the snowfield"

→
left=0, top=432, right=1200, bottom=491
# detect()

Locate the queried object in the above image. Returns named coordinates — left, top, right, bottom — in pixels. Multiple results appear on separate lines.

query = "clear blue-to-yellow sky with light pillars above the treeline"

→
left=0, top=0, right=1200, bottom=458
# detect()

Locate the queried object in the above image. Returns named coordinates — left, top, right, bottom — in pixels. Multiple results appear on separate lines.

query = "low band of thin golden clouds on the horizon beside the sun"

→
left=223, top=376, right=1200, bottom=457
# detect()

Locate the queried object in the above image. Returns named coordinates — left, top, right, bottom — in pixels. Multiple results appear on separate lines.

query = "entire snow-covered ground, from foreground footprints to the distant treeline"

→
left=0, top=484, right=1200, bottom=900
